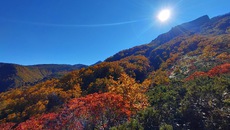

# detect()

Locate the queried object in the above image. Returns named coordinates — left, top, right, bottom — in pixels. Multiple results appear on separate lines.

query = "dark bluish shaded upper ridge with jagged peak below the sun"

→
left=105, top=13, right=230, bottom=66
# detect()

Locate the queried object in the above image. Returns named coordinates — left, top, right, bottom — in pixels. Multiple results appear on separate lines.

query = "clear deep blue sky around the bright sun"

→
left=0, top=0, right=230, bottom=65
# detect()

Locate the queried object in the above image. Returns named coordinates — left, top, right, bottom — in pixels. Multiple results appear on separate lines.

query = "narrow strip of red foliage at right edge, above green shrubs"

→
left=185, top=63, right=230, bottom=81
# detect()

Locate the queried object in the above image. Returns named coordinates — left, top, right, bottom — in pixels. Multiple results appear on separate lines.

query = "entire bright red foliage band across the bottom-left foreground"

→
left=14, top=93, right=131, bottom=130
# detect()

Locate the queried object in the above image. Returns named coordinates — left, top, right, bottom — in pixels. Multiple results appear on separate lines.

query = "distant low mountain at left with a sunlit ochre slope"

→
left=0, top=63, right=87, bottom=92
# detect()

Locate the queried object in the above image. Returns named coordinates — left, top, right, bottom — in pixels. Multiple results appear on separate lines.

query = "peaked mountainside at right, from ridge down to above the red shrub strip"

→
left=105, top=13, right=230, bottom=77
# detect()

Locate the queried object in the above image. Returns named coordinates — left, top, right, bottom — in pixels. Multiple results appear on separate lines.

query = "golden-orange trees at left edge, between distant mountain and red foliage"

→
left=0, top=80, right=81, bottom=122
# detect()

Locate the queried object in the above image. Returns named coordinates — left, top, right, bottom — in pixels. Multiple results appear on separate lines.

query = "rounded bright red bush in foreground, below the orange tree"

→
left=54, top=93, right=131, bottom=129
